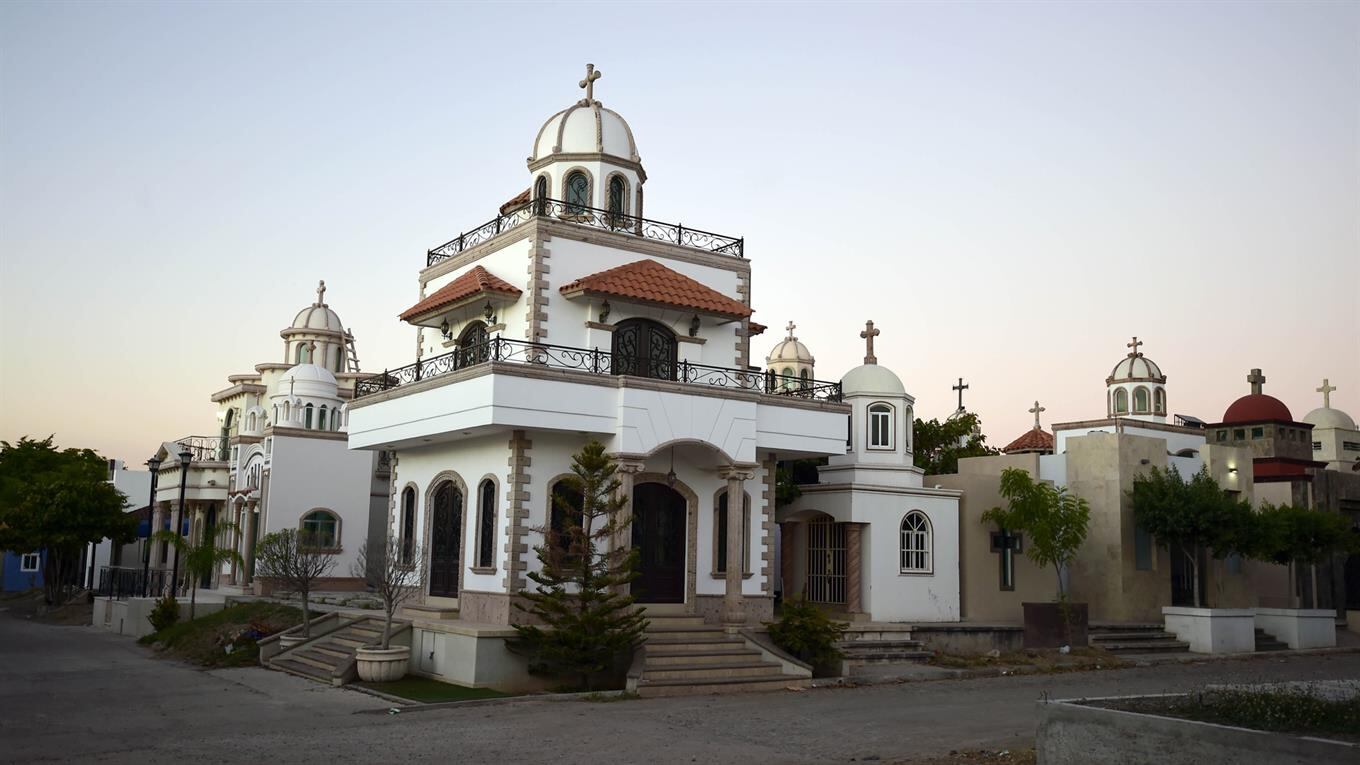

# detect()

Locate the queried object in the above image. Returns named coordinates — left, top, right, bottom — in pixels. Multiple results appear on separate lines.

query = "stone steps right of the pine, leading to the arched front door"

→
left=630, top=614, right=812, bottom=697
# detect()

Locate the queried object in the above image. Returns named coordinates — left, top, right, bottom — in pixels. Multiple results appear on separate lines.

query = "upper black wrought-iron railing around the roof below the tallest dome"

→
left=426, top=199, right=745, bottom=265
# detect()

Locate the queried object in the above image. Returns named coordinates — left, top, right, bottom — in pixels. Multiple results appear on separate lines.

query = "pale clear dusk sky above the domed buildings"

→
left=0, top=1, right=1360, bottom=463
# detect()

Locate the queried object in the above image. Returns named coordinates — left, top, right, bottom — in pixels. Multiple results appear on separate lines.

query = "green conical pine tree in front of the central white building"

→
left=513, top=441, right=647, bottom=690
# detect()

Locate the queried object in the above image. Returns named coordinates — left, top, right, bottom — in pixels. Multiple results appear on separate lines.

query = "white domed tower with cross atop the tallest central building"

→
left=528, top=64, right=647, bottom=219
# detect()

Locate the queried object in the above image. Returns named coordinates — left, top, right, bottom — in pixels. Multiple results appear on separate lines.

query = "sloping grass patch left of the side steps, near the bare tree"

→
left=137, top=603, right=302, bottom=667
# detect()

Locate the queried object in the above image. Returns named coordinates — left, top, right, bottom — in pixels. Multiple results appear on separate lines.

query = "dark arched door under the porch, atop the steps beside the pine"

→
left=632, top=483, right=685, bottom=603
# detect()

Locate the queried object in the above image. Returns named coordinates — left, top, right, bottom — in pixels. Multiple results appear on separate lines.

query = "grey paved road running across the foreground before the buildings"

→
left=0, top=614, right=1360, bottom=765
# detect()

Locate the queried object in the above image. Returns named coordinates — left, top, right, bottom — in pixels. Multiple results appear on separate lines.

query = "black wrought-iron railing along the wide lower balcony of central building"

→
left=354, top=338, right=840, bottom=402
